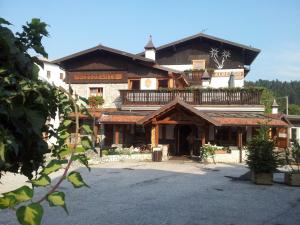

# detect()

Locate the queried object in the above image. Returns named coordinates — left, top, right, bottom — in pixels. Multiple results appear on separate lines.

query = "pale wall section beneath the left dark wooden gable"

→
left=71, top=83, right=128, bottom=108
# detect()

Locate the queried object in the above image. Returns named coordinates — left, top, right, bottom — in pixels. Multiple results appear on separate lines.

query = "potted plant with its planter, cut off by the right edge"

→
left=284, top=140, right=300, bottom=186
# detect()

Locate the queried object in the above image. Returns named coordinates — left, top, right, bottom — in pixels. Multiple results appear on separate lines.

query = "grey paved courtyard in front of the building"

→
left=0, top=161, right=300, bottom=225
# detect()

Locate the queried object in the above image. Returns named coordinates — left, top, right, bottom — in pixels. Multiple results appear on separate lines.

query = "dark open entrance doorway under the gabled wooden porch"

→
left=176, top=125, right=195, bottom=155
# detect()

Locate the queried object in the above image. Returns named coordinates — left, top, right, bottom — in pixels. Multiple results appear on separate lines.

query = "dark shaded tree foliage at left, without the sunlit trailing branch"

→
left=0, top=19, right=58, bottom=179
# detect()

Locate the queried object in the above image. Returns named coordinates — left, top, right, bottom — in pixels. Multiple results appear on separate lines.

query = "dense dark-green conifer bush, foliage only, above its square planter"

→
left=246, top=127, right=279, bottom=173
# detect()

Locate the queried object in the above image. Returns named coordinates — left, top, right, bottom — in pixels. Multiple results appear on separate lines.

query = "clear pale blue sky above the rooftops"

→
left=0, top=0, right=300, bottom=81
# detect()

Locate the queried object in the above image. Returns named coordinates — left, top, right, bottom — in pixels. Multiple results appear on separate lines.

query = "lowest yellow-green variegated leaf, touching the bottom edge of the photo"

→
left=16, top=203, right=44, bottom=225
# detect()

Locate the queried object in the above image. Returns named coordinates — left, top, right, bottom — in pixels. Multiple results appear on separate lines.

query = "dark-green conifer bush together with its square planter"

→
left=246, top=126, right=279, bottom=185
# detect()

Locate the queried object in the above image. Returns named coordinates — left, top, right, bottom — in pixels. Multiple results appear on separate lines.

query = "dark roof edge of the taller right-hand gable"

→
left=137, top=33, right=260, bottom=65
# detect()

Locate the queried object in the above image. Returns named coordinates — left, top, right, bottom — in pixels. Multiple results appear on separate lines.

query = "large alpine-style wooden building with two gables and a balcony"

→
left=54, top=33, right=288, bottom=159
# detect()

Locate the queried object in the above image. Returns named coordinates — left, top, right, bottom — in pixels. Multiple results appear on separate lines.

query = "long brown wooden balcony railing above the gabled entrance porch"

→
left=120, top=89, right=262, bottom=106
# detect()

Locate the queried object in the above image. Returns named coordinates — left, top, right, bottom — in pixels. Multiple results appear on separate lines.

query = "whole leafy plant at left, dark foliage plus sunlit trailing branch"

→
left=0, top=18, right=92, bottom=225
